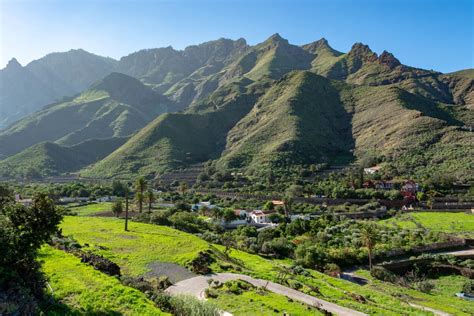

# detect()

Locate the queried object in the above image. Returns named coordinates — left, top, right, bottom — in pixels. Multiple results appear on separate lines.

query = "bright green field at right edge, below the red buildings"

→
left=381, top=212, right=474, bottom=237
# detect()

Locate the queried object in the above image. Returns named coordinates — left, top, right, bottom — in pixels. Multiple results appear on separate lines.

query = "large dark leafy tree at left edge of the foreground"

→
left=0, top=194, right=62, bottom=315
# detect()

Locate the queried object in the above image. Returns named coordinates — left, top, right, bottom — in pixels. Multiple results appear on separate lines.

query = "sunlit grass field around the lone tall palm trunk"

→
left=61, top=216, right=208, bottom=275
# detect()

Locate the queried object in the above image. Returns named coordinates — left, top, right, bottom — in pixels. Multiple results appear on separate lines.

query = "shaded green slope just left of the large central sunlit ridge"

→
left=81, top=81, right=267, bottom=178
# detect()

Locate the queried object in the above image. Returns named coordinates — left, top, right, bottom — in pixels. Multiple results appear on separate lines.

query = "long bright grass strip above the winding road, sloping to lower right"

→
left=54, top=216, right=460, bottom=315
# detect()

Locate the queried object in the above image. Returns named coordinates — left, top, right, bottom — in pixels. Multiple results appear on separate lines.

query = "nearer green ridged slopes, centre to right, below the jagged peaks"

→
left=82, top=71, right=474, bottom=181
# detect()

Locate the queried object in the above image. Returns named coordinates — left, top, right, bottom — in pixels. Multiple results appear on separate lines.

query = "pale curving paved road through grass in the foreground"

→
left=166, top=273, right=366, bottom=316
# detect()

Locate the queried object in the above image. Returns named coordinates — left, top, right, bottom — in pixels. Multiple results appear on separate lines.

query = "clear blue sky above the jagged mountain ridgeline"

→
left=0, top=0, right=474, bottom=72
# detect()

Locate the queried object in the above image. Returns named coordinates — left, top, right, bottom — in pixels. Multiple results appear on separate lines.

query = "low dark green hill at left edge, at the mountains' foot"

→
left=0, top=137, right=127, bottom=178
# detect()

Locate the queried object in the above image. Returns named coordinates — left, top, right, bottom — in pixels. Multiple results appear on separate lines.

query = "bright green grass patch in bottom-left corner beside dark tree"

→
left=39, top=246, right=167, bottom=315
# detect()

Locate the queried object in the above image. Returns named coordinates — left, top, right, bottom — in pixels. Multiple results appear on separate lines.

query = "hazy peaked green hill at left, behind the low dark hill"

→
left=0, top=73, right=178, bottom=157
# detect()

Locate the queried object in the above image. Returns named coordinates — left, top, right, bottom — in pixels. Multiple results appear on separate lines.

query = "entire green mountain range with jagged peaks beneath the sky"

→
left=0, top=34, right=474, bottom=180
